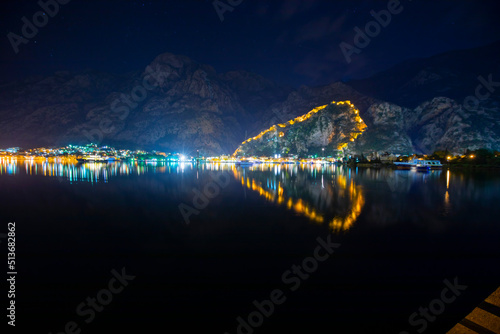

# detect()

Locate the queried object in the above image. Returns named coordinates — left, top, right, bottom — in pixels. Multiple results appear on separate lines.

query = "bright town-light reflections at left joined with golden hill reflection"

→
left=0, top=159, right=364, bottom=231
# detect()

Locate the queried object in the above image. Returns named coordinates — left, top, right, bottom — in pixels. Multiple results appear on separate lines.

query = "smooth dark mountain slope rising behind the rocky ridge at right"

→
left=349, top=41, right=500, bottom=108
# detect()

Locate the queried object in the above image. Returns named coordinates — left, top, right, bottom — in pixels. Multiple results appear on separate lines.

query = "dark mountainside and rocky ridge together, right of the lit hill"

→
left=349, top=42, right=500, bottom=154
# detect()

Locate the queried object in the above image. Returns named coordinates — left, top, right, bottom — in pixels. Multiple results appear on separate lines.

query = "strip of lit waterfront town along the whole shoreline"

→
left=0, top=143, right=500, bottom=167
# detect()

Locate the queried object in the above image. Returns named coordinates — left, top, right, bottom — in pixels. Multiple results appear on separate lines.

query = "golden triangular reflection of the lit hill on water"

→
left=233, top=164, right=365, bottom=232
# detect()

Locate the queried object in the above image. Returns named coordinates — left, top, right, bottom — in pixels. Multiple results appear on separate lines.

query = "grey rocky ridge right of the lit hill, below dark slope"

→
left=350, top=97, right=500, bottom=154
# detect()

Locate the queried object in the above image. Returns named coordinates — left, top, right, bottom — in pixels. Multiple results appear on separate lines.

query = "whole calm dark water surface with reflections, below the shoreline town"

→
left=0, top=160, right=500, bottom=334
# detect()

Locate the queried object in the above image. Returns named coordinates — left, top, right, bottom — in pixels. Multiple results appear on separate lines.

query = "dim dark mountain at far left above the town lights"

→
left=0, top=72, right=126, bottom=146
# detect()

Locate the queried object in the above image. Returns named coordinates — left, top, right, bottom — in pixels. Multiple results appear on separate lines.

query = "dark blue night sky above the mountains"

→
left=0, top=0, right=500, bottom=86
